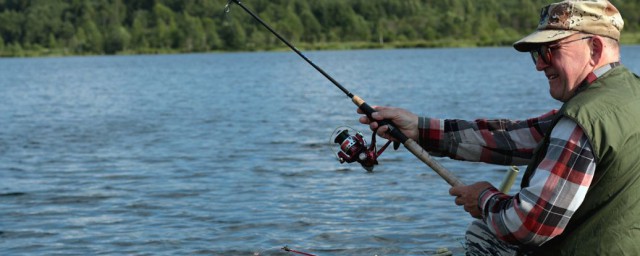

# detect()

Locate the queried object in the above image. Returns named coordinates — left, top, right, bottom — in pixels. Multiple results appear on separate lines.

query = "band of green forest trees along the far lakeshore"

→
left=0, top=0, right=640, bottom=56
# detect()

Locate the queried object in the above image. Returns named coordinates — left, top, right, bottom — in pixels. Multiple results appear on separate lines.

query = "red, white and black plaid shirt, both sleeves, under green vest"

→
left=418, top=110, right=596, bottom=245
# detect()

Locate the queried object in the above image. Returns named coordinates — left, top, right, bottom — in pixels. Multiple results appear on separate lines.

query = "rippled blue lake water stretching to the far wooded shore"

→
left=0, top=46, right=640, bottom=255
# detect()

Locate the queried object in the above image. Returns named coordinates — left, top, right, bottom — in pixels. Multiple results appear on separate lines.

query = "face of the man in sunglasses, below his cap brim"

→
left=536, top=34, right=591, bottom=102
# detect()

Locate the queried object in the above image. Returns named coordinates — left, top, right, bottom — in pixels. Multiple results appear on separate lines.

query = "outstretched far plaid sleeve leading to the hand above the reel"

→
left=418, top=110, right=557, bottom=165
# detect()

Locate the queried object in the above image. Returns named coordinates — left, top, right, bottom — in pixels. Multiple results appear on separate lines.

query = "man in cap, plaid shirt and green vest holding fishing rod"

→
left=359, top=0, right=640, bottom=255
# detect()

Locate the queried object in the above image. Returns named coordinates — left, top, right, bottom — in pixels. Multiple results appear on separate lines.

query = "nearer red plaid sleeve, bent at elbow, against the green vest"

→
left=479, top=118, right=596, bottom=245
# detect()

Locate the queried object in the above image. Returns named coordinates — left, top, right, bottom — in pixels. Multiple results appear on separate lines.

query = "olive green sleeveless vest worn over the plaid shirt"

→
left=522, top=66, right=640, bottom=255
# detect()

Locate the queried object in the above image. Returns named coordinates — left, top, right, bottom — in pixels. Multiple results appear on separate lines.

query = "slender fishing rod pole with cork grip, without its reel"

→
left=225, top=0, right=464, bottom=186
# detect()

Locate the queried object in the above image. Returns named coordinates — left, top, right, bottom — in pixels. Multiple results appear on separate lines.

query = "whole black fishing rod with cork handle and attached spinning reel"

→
left=225, top=0, right=464, bottom=187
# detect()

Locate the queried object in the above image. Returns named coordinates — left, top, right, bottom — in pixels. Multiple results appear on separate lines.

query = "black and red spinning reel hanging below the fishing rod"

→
left=331, top=127, right=391, bottom=172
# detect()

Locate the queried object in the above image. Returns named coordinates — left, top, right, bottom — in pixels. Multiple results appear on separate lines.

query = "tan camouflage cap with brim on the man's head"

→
left=513, top=0, right=624, bottom=52
